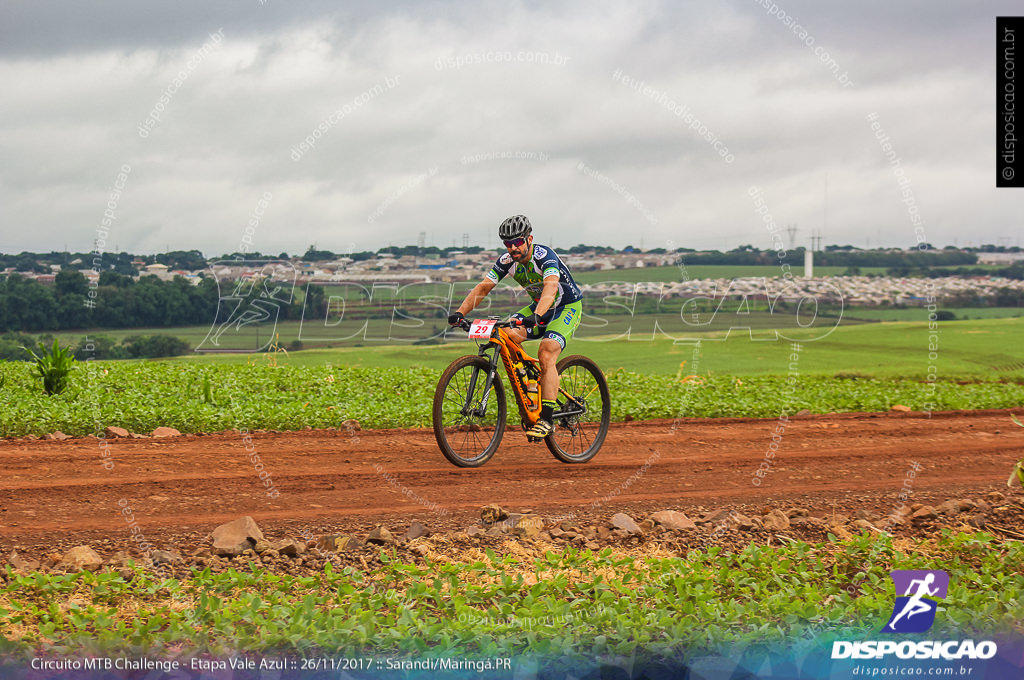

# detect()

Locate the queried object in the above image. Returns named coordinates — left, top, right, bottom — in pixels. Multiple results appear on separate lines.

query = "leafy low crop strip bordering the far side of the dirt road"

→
left=0, top=343, right=1024, bottom=436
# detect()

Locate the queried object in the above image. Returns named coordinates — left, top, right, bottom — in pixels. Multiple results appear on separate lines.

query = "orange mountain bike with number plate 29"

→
left=432, top=316, right=611, bottom=467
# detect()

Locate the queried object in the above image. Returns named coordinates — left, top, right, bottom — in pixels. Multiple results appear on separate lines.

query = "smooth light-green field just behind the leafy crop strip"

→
left=157, top=315, right=1024, bottom=378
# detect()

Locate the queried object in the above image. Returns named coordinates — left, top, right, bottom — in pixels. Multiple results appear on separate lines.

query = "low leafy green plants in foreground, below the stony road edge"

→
left=0, top=530, right=1024, bottom=663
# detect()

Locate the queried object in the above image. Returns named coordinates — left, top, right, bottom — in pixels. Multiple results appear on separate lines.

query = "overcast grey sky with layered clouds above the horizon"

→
left=0, top=0, right=1024, bottom=255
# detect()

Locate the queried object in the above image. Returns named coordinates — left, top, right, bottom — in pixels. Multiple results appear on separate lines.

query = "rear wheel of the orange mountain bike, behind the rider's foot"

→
left=544, top=354, right=611, bottom=463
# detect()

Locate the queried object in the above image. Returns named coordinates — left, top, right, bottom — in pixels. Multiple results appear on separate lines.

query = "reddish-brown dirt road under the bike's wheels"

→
left=0, top=411, right=1024, bottom=554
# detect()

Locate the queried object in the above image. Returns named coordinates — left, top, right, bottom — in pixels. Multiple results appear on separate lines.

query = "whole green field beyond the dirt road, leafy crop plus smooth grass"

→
left=0, top=318, right=1024, bottom=436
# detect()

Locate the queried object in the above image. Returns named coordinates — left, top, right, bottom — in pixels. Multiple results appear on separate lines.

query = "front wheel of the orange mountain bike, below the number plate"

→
left=432, top=355, right=508, bottom=467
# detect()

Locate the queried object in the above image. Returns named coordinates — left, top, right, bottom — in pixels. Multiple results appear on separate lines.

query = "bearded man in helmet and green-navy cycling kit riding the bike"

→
left=449, top=215, right=583, bottom=439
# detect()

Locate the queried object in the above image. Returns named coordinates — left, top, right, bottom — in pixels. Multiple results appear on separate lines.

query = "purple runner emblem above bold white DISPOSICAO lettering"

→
left=831, top=569, right=997, bottom=661
